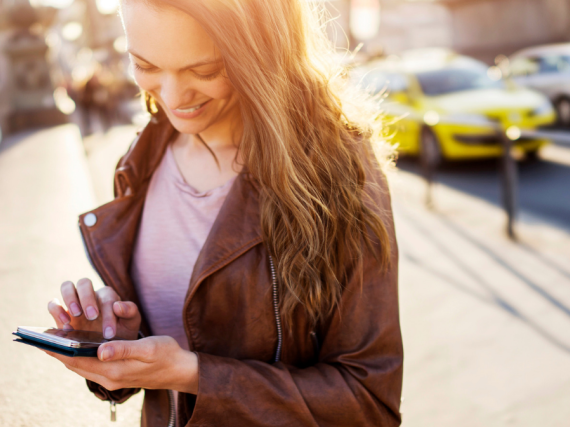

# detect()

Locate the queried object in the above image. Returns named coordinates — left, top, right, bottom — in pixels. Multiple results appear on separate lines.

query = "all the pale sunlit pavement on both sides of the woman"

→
left=0, top=126, right=570, bottom=427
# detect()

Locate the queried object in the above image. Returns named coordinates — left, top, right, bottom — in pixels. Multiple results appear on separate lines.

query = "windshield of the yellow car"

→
left=416, top=68, right=504, bottom=96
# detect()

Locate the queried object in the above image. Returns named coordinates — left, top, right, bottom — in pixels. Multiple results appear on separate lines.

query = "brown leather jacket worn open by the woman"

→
left=79, top=115, right=403, bottom=427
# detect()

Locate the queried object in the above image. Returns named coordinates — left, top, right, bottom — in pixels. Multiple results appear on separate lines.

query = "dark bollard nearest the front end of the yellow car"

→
left=497, top=128, right=520, bottom=240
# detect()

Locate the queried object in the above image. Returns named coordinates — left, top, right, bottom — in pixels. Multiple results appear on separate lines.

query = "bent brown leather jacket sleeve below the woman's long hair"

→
left=188, top=169, right=403, bottom=427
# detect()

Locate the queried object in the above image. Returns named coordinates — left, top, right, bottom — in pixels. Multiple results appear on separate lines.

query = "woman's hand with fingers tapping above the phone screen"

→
left=48, top=279, right=141, bottom=340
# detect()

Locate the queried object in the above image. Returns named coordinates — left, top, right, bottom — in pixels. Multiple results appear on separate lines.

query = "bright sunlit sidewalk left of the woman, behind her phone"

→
left=0, top=125, right=142, bottom=427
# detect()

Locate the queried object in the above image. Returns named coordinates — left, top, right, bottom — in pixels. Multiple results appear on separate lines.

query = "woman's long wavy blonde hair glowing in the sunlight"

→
left=138, top=0, right=390, bottom=324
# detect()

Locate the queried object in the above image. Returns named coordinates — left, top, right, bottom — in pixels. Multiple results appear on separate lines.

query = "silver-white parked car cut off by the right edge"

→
left=500, top=43, right=570, bottom=127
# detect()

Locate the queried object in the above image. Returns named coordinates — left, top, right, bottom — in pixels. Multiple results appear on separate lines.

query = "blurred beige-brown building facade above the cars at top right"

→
left=327, top=0, right=570, bottom=63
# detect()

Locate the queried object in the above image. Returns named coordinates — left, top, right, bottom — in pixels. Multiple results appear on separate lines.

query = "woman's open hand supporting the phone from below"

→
left=42, top=336, right=198, bottom=394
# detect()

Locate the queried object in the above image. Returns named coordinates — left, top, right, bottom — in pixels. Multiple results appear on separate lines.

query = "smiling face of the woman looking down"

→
left=122, top=0, right=239, bottom=134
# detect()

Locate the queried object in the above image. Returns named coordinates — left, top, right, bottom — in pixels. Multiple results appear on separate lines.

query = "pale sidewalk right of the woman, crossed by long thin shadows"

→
left=392, top=171, right=570, bottom=427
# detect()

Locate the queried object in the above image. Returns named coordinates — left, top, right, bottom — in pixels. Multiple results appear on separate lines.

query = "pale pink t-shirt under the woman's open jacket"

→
left=131, top=145, right=235, bottom=350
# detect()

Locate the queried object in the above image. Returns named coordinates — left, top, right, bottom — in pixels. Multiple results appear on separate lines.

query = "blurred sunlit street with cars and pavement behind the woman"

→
left=0, top=0, right=570, bottom=427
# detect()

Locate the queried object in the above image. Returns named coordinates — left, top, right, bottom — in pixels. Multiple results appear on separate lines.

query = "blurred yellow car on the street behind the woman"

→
left=357, top=50, right=556, bottom=165
